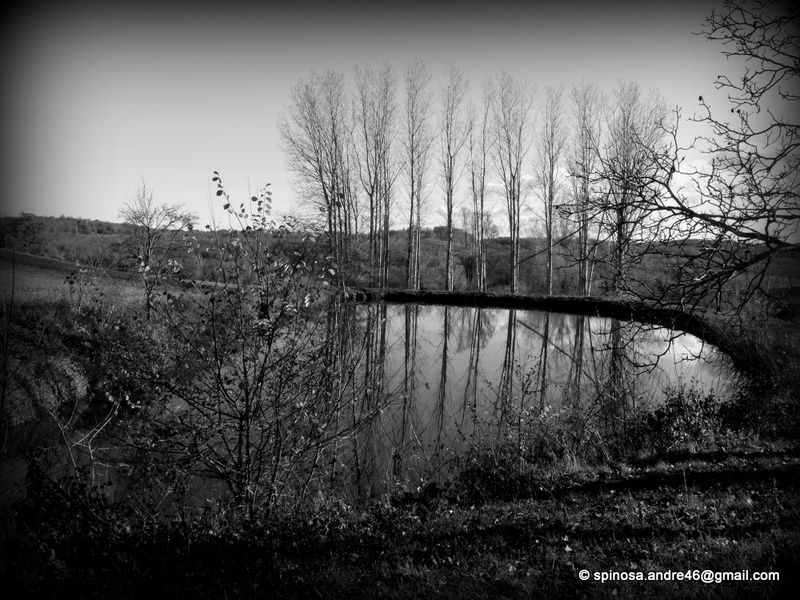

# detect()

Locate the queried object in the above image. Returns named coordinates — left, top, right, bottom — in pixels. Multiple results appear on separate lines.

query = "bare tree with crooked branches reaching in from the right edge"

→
left=636, top=0, right=800, bottom=312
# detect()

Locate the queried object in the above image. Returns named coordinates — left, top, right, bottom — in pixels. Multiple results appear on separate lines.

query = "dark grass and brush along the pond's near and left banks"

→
left=0, top=238, right=800, bottom=598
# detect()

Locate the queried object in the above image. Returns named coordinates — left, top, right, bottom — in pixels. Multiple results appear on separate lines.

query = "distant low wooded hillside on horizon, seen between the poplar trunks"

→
left=0, top=206, right=776, bottom=300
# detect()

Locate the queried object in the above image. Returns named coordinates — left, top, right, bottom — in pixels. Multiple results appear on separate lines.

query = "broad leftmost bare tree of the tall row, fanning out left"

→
left=279, top=71, right=357, bottom=280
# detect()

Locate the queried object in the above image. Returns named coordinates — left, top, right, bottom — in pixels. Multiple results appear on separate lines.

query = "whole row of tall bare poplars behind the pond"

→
left=280, top=60, right=669, bottom=294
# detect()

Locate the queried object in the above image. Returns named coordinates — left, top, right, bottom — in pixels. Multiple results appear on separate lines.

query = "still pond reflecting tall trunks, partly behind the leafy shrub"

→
left=12, top=302, right=735, bottom=510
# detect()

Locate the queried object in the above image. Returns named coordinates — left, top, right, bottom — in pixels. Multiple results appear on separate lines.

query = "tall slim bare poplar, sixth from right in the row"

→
left=441, top=65, right=469, bottom=291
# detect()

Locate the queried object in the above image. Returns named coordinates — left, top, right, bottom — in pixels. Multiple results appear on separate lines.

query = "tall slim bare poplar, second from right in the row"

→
left=568, top=81, right=601, bottom=296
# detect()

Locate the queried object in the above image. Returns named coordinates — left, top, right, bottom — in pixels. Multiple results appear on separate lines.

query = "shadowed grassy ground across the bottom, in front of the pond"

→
left=1, top=444, right=800, bottom=599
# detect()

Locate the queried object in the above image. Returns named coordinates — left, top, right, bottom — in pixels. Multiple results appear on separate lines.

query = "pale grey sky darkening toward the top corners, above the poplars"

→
left=0, top=0, right=732, bottom=230
